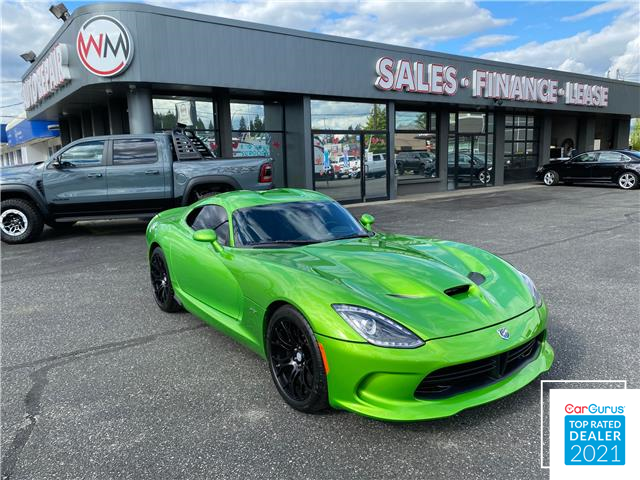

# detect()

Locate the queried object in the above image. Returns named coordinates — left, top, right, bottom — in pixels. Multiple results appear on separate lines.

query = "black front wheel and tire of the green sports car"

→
left=265, top=305, right=329, bottom=413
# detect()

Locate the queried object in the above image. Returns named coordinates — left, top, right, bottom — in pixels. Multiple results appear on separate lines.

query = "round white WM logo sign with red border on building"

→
left=76, top=15, right=133, bottom=77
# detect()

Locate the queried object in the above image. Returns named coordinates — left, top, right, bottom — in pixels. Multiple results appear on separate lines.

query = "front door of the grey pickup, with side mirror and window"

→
left=42, top=140, right=107, bottom=216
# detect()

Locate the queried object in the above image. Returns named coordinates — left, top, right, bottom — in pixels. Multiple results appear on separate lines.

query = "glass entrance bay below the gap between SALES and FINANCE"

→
left=447, top=112, right=494, bottom=190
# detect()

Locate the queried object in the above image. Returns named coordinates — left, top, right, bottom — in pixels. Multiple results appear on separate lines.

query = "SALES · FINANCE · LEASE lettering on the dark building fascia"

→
left=374, top=57, right=609, bottom=107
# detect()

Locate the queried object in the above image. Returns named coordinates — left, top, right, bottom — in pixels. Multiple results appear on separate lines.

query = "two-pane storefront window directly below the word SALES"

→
left=394, top=110, right=438, bottom=184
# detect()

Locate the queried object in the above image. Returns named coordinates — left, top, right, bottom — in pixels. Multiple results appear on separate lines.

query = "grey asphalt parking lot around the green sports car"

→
left=1, top=186, right=640, bottom=480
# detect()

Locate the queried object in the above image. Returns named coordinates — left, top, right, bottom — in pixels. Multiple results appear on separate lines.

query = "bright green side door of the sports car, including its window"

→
left=171, top=205, right=243, bottom=319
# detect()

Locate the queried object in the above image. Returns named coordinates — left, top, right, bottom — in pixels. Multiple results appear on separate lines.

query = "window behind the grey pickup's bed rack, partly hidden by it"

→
left=153, top=96, right=220, bottom=157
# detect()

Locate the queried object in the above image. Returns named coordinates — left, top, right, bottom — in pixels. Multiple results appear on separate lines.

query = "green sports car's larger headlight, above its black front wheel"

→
left=332, top=305, right=424, bottom=348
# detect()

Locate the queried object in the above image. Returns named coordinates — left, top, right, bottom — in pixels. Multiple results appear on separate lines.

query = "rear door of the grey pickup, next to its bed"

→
left=106, top=137, right=171, bottom=212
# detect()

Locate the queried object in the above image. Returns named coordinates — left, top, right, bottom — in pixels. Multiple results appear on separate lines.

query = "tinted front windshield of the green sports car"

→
left=233, top=202, right=369, bottom=248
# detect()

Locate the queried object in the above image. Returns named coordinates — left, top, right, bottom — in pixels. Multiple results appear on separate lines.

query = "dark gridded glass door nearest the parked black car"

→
left=504, top=114, right=538, bottom=183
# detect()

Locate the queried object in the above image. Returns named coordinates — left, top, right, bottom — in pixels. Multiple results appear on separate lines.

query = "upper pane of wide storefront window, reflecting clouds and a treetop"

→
left=311, top=100, right=387, bottom=131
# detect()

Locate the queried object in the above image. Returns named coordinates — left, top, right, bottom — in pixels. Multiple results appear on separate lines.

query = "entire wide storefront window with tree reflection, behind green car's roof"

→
left=311, top=100, right=389, bottom=201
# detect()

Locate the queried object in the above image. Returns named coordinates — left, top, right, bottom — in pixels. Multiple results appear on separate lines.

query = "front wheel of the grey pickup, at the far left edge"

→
left=0, top=198, right=44, bottom=243
